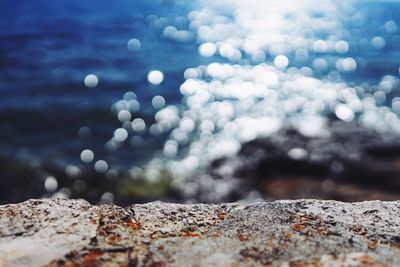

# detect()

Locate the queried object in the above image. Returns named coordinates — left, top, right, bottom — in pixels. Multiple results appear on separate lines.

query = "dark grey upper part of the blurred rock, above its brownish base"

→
left=234, top=122, right=400, bottom=187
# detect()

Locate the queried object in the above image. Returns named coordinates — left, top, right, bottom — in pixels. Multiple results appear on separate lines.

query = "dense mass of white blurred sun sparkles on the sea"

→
left=101, top=0, right=400, bottom=197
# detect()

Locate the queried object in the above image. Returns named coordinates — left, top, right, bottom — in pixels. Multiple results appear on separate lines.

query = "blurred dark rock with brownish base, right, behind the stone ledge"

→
left=222, top=122, right=400, bottom=201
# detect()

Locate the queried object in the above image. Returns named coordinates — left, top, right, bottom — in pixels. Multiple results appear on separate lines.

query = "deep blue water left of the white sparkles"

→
left=0, top=0, right=205, bottom=168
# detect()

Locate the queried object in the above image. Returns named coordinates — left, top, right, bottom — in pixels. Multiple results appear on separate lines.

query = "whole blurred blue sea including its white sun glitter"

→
left=0, top=0, right=400, bottom=201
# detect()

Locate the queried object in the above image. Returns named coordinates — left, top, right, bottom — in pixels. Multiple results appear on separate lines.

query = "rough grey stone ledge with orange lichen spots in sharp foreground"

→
left=0, top=199, right=400, bottom=266
